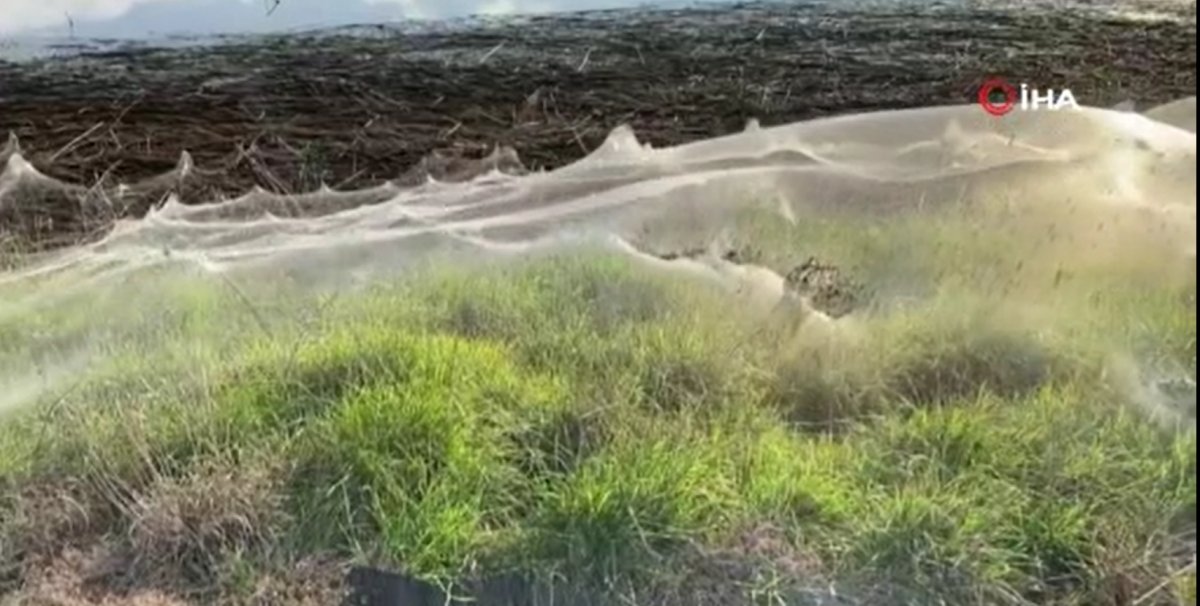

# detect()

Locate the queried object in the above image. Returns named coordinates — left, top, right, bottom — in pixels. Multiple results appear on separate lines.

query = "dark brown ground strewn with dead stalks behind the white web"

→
left=0, top=0, right=1196, bottom=217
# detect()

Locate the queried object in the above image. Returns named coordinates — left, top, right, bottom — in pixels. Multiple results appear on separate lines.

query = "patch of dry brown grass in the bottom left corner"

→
left=0, top=461, right=295, bottom=606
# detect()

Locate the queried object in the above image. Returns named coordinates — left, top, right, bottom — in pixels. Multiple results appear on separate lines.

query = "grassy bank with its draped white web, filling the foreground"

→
left=0, top=100, right=1196, bottom=606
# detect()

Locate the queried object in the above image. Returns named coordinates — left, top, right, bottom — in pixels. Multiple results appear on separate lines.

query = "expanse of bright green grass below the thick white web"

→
left=0, top=210, right=1196, bottom=605
